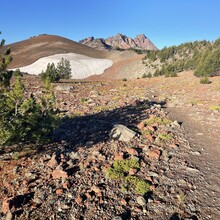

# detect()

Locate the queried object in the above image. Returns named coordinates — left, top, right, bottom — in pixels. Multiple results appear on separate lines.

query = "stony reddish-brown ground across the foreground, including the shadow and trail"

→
left=0, top=73, right=220, bottom=220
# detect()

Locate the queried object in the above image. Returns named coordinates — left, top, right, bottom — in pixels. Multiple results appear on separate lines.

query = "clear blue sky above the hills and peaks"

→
left=0, top=0, right=220, bottom=48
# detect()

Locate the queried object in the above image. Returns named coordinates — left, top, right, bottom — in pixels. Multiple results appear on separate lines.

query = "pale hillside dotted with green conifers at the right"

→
left=143, top=39, right=220, bottom=76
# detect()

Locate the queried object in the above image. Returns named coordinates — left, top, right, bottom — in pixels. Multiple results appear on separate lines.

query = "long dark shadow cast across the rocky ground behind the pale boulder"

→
left=51, top=100, right=165, bottom=152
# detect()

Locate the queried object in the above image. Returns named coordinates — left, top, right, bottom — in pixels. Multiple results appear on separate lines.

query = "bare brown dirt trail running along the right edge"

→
left=168, top=108, right=220, bottom=219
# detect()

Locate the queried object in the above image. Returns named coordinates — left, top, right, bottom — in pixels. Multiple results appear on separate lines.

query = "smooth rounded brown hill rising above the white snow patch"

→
left=6, top=35, right=106, bottom=68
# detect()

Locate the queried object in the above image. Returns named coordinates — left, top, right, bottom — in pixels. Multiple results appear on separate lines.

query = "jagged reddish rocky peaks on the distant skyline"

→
left=79, top=34, right=158, bottom=50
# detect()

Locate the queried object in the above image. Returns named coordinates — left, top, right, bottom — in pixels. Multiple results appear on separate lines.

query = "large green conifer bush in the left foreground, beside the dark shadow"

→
left=0, top=76, right=57, bottom=147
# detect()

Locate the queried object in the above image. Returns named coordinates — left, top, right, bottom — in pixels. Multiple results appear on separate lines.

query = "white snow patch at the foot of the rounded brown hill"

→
left=13, top=53, right=113, bottom=79
